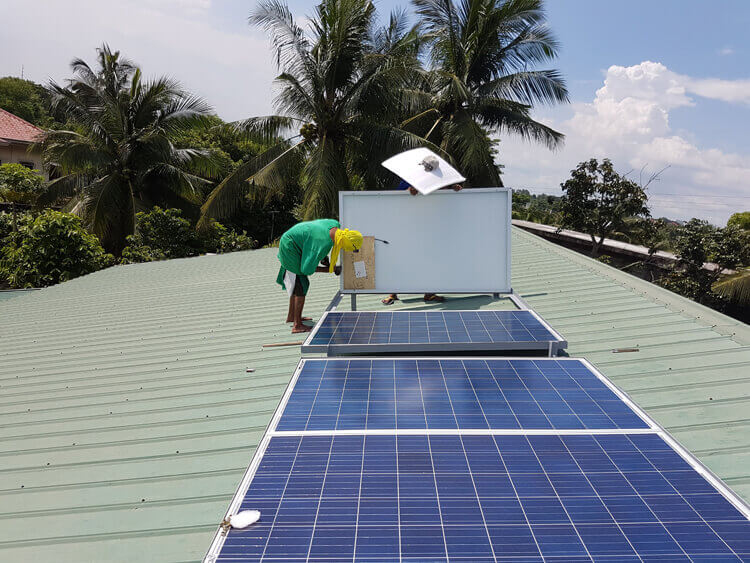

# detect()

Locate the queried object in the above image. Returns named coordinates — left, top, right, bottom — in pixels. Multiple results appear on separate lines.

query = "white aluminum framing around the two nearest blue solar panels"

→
left=203, top=357, right=750, bottom=563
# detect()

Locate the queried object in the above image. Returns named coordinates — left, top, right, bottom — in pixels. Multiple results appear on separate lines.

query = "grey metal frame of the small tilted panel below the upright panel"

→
left=300, top=309, right=568, bottom=357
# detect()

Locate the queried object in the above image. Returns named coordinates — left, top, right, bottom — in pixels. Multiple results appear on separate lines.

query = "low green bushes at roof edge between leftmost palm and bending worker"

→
left=122, top=207, right=255, bottom=264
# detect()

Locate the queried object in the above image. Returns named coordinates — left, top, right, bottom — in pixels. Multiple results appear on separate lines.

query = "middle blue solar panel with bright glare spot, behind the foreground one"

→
left=275, top=358, right=648, bottom=431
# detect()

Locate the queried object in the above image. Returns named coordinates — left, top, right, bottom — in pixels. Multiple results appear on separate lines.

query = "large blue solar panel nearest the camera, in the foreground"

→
left=219, top=434, right=750, bottom=563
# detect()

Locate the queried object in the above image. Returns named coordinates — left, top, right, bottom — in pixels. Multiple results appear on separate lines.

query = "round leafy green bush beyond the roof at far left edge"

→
left=0, top=210, right=113, bottom=288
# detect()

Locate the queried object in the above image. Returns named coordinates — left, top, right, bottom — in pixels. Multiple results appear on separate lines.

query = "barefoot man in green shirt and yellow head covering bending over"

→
left=276, top=219, right=362, bottom=334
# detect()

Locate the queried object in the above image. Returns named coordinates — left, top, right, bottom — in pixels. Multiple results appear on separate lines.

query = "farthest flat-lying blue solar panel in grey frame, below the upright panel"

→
left=302, top=310, right=567, bottom=355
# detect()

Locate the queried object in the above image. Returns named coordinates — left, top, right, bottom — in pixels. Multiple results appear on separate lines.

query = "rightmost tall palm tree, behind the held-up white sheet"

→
left=403, top=0, right=568, bottom=186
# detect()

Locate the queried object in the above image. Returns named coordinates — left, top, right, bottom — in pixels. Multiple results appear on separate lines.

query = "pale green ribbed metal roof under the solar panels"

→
left=0, top=229, right=750, bottom=561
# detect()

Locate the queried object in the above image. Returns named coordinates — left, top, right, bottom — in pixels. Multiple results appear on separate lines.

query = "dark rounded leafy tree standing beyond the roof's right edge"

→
left=560, top=158, right=651, bottom=257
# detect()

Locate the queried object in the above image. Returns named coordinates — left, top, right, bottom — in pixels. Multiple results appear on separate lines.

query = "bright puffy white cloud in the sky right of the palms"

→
left=500, top=61, right=750, bottom=224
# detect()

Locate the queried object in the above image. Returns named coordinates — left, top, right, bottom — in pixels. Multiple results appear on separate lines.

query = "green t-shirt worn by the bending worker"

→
left=279, top=219, right=341, bottom=276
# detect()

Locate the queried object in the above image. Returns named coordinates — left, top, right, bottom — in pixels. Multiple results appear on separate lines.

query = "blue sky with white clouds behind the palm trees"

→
left=0, top=0, right=750, bottom=224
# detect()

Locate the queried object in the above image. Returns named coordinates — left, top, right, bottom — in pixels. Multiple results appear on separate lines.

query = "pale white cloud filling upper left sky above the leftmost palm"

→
left=0, top=0, right=276, bottom=119
